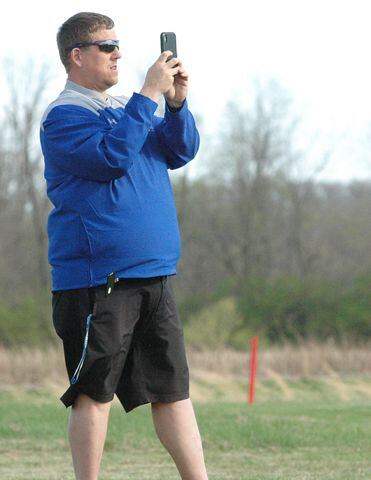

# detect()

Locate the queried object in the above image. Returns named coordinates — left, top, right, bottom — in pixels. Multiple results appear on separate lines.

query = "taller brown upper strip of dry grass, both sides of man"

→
left=0, top=342, right=371, bottom=385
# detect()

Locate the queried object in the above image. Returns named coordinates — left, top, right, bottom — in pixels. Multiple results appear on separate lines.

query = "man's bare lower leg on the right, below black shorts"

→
left=152, top=398, right=208, bottom=480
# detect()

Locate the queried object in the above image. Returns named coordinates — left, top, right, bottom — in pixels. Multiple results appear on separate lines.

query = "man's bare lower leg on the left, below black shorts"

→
left=68, top=394, right=112, bottom=480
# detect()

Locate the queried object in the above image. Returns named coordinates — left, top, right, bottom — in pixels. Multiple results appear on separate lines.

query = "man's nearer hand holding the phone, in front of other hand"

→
left=140, top=50, right=180, bottom=102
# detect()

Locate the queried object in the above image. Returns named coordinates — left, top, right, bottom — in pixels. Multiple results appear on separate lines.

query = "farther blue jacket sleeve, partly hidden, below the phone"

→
left=155, top=100, right=200, bottom=170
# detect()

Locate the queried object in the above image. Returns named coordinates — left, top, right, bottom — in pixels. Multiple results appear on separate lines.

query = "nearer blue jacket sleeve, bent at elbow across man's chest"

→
left=41, top=93, right=157, bottom=181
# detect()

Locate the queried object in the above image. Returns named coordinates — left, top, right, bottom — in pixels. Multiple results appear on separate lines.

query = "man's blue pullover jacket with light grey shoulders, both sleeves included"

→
left=40, top=81, right=199, bottom=290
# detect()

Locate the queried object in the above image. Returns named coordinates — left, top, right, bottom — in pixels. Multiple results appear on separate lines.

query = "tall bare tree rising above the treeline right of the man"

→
left=199, top=83, right=297, bottom=284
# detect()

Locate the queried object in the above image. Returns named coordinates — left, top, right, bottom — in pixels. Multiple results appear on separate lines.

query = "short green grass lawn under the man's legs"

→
left=0, top=390, right=371, bottom=480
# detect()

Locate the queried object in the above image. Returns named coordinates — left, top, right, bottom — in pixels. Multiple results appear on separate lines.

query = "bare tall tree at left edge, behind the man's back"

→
left=1, top=60, right=51, bottom=288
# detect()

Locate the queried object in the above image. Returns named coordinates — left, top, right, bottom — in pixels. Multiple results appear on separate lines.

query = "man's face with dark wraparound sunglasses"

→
left=75, top=29, right=121, bottom=92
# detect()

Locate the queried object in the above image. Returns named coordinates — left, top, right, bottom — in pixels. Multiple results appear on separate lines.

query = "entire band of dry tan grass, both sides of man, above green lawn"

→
left=0, top=342, right=371, bottom=401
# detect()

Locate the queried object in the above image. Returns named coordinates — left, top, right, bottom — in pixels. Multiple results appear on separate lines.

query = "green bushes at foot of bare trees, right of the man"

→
left=182, top=274, right=371, bottom=350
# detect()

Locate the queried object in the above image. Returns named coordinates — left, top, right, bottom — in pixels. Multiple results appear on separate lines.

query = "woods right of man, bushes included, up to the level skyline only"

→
left=176, top=171, right=371, bottom=348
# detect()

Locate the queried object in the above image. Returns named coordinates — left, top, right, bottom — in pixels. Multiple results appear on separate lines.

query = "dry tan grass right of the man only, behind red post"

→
left=188, top=342, right=371, bottom=402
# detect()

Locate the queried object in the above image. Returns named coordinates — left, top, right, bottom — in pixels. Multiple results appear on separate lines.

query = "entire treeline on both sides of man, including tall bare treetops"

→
left=0, top=63, right=371, bottom=348
